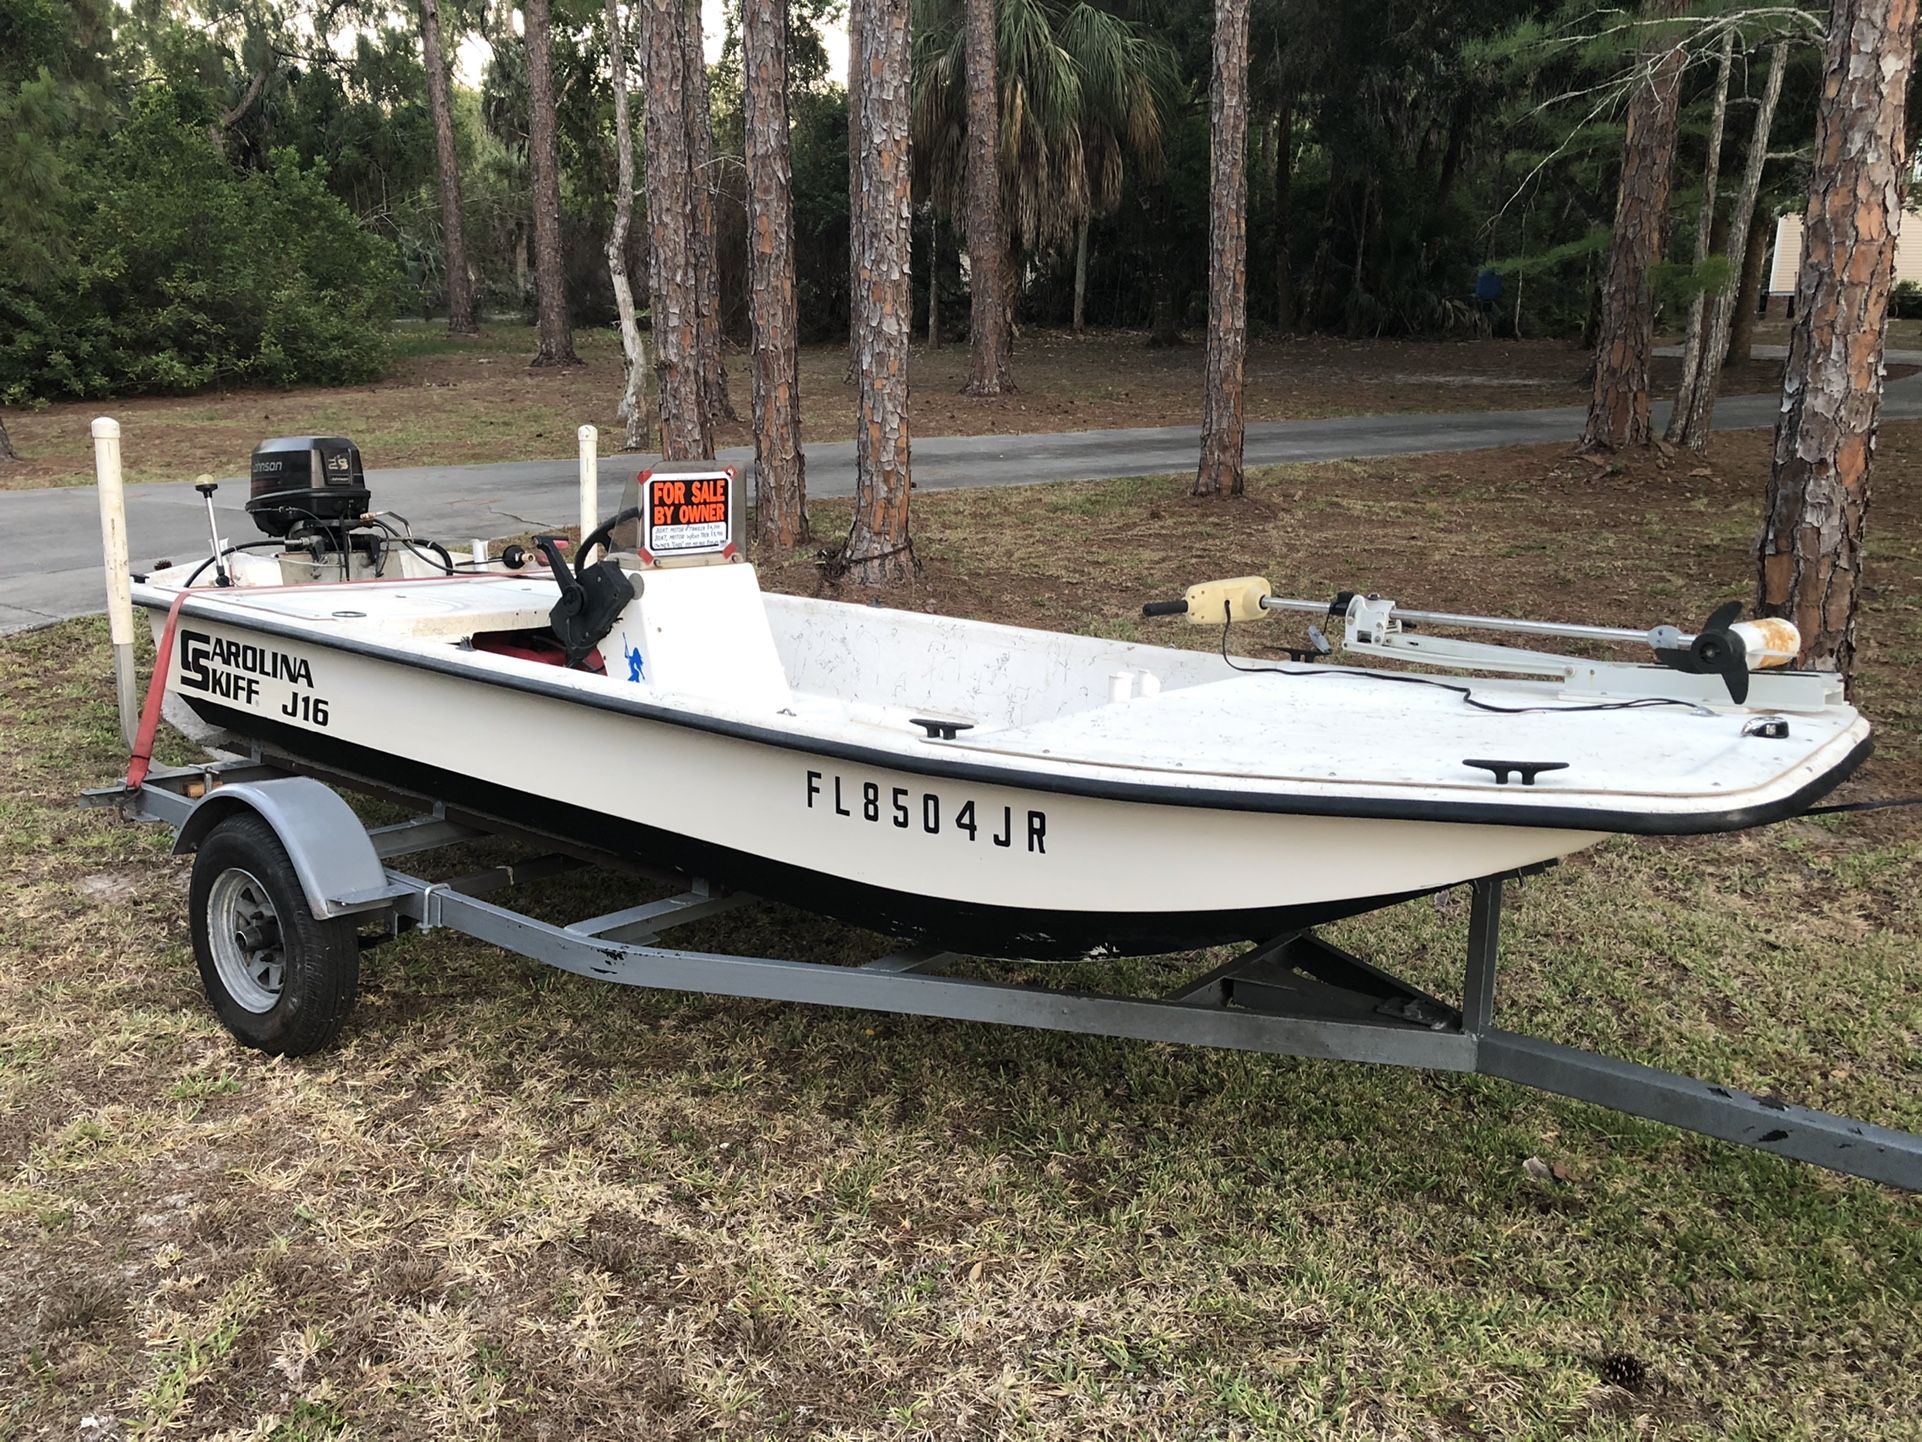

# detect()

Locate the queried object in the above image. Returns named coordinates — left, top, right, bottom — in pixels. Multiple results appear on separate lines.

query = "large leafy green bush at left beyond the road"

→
left=0, top=92, right=400, bottom=402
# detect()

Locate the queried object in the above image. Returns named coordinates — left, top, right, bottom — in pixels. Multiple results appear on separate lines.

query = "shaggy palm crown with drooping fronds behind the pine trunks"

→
left=915, top=0, right=1176, bottom=330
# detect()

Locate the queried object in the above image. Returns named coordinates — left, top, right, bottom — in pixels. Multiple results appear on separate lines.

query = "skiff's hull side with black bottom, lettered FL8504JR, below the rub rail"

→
left=171, top=619, right=1603, bottom=957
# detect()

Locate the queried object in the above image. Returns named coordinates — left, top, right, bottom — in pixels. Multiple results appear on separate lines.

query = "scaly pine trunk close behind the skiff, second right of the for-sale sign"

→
left=844, top=0, right=915, bottom=586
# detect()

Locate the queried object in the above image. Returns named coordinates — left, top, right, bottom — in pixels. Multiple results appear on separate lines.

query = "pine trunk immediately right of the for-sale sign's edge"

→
left=745, top=0, right=807, bottom=550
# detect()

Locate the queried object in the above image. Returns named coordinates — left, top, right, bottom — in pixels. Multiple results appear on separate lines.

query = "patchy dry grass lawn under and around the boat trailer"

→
left=0, top=425, right=1922, bottom=1442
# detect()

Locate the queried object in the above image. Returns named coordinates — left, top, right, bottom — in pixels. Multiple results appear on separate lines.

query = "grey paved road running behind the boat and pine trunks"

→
left=0, top=346, right=1922, bottom=634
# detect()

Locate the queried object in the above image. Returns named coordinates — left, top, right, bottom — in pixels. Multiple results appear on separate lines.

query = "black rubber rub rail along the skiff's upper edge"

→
left=148, top=598, right=1874, bottom=836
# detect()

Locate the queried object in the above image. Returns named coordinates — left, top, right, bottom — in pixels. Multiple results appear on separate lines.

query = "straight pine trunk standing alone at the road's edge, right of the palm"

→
left=1194, top=0, right=1249, bottom=496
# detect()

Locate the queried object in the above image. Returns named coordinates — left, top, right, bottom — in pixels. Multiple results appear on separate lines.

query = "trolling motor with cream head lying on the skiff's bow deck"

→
left=1142, top=577, right=1801, bottom=706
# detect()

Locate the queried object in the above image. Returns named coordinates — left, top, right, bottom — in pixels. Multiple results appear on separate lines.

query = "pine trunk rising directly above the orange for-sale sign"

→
left=640, top=0, right=713, bottom=461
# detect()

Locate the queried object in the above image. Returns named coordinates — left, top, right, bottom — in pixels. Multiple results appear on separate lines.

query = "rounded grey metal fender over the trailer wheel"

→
left=173, top=777, right=394, bottom=919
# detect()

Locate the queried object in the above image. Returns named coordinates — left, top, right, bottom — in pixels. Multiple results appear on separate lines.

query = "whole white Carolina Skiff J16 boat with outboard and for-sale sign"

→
left=133, top=438, right=1870, bottom=957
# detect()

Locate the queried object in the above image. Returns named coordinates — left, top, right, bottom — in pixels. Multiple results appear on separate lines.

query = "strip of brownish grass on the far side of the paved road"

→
left=0, top=325, right=1782, bottom=490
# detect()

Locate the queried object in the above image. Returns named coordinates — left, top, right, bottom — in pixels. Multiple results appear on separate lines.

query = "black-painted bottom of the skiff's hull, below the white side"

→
left=186, top=698, right=1426, bottom=961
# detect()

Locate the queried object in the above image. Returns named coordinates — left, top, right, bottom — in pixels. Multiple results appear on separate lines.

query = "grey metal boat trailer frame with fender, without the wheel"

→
left=86, top=756, right=1922, bottom=1192
